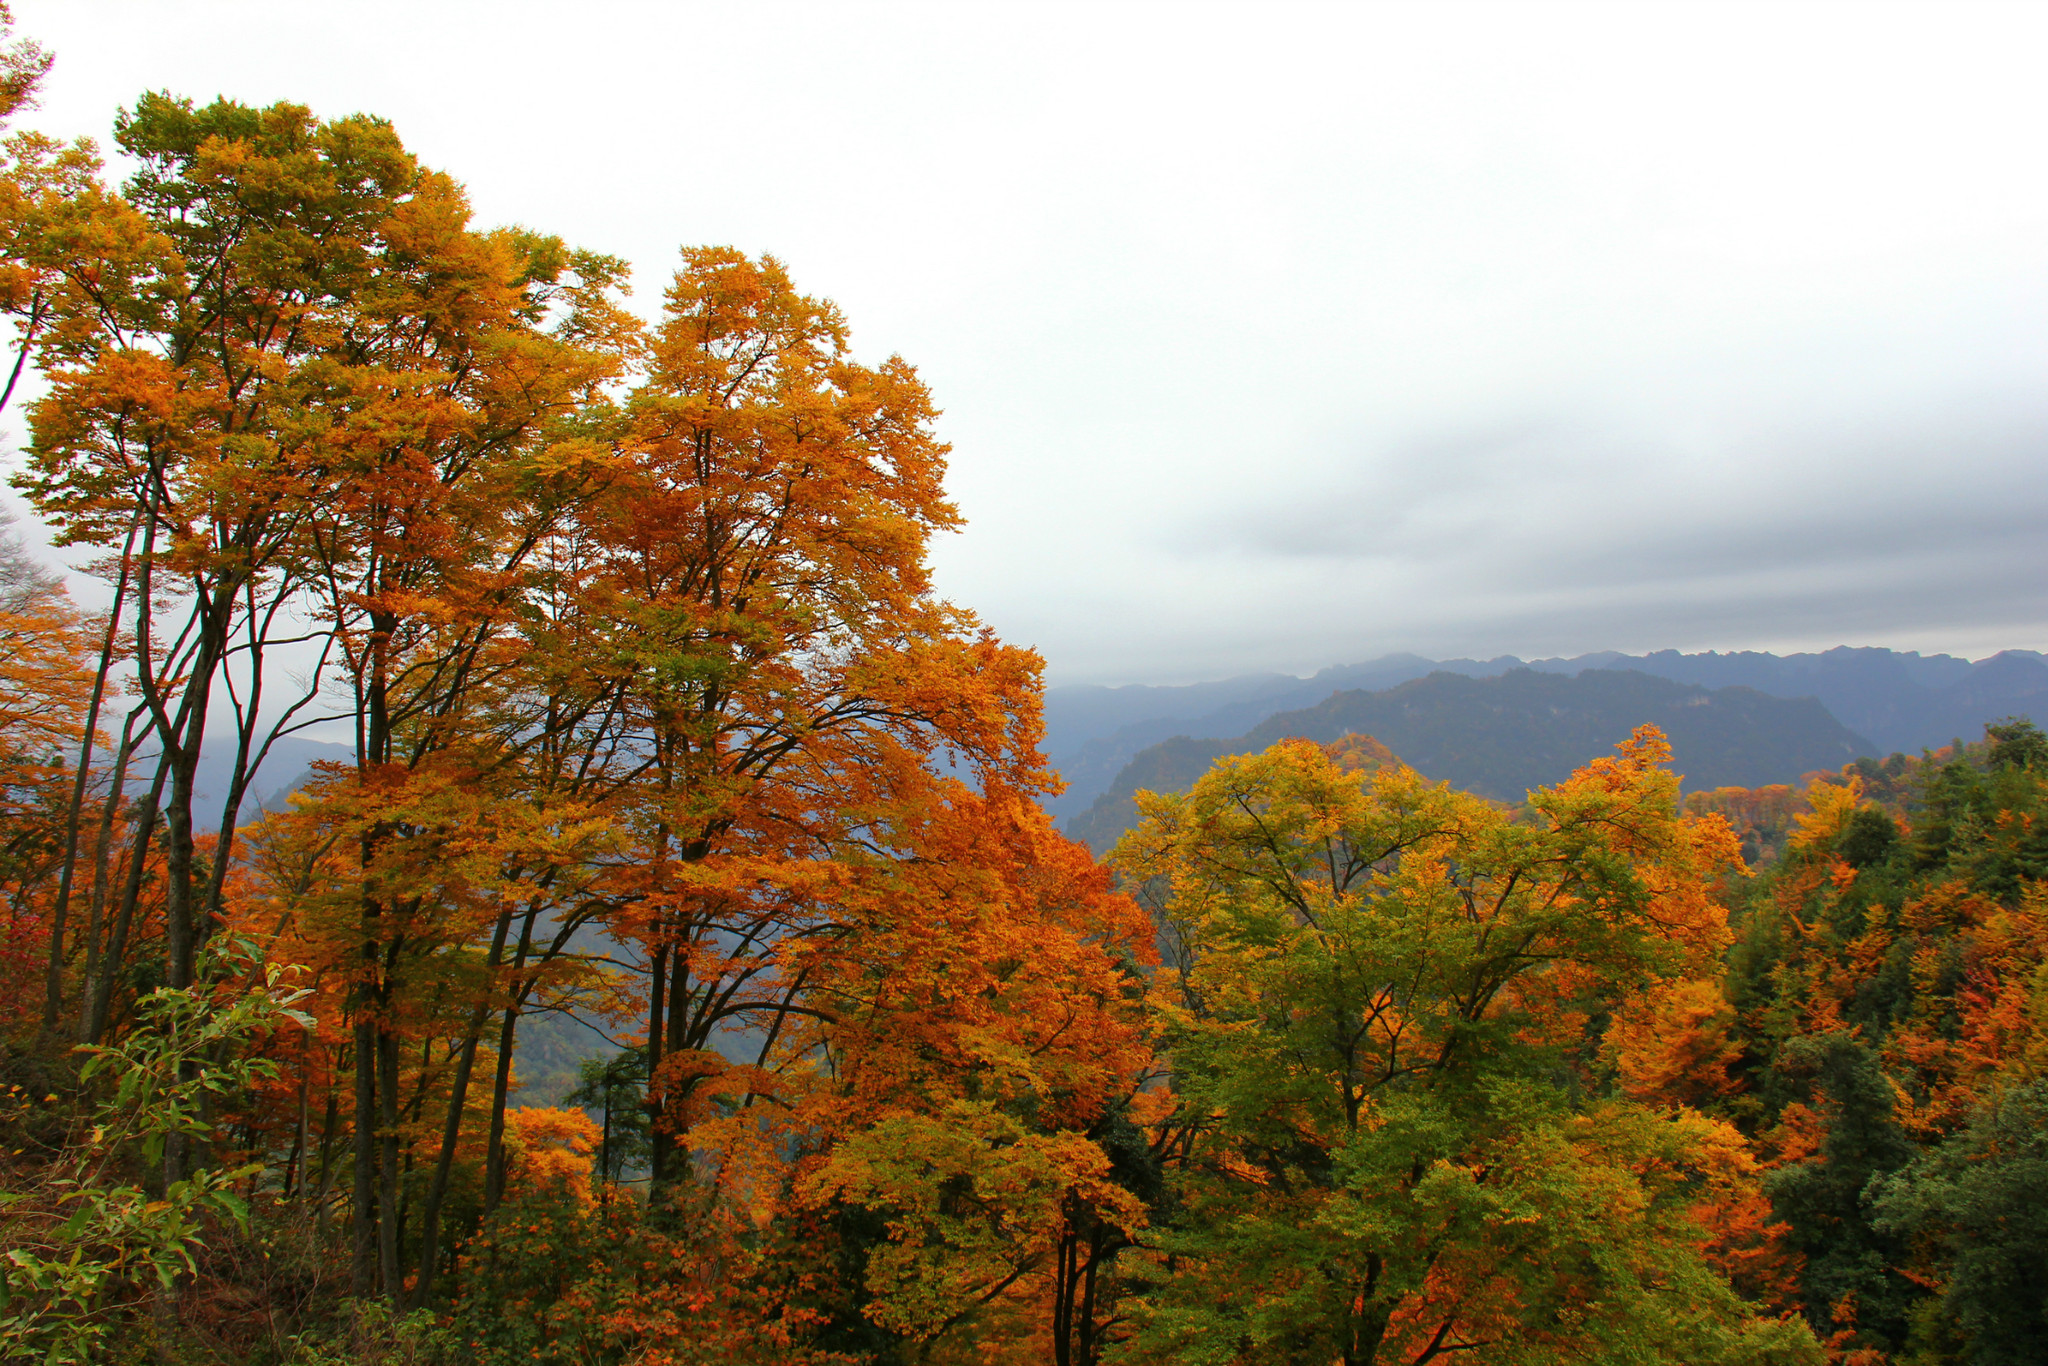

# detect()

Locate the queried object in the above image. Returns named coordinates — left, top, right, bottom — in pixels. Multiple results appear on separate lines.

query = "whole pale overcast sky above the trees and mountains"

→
left=14, top=0, right=2048, bottom=682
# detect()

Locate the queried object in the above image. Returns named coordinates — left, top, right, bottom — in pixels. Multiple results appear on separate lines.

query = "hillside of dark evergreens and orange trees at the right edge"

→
left=1671, top=721, right=2048, bottom=1362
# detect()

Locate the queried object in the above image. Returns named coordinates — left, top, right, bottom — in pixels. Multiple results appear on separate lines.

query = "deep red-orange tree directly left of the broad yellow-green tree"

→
left=791, top=784, right=1153, bottom=1362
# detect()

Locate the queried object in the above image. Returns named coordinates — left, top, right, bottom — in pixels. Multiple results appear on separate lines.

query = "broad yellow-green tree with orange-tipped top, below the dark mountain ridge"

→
left=1114, top=727, right=1817, bottom=1364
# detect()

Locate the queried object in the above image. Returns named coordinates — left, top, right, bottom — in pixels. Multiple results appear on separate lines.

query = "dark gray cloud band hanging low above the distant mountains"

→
left=1161, top=370, right=2048, bottom=675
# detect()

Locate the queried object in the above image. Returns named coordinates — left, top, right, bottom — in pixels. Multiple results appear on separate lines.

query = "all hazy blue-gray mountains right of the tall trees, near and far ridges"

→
left=1047, top=647, right=2048, bottom=848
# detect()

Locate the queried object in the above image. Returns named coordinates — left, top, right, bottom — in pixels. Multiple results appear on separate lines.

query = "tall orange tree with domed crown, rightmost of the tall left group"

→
left=578, top=248, right=1007, bottom=1186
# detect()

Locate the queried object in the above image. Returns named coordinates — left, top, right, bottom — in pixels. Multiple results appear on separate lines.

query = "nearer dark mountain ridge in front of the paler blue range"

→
left=1067, top=668, right=1872, bottom=854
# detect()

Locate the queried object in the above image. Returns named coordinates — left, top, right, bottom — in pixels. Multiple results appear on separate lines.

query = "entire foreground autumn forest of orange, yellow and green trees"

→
left=0, top=10, right=2048, bottom=1366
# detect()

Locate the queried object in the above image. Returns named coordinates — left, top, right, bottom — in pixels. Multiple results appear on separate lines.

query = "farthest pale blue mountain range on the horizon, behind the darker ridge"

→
left=1047, top=645, right=2048, bottom=821
